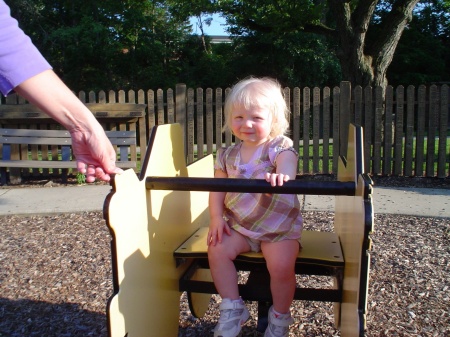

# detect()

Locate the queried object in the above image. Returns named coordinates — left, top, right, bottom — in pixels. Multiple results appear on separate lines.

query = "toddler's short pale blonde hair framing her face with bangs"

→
left=223, top=77, right=290, bottom=137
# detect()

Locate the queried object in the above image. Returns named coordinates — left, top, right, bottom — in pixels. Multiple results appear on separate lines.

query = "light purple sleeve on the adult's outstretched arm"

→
left=0, top=0, right=52, bottom=95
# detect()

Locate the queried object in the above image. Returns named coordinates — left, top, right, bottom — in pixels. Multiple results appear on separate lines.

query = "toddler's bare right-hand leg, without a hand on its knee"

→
left=261, top=240, right=299, bottom=314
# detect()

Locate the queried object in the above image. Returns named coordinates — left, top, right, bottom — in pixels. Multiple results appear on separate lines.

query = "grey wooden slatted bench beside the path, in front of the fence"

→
left=0, top=129, right=136, bottom=185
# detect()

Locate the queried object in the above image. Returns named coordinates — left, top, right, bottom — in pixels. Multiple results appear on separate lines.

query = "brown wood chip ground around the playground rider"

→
left=0, top=212, right=450, bottom=337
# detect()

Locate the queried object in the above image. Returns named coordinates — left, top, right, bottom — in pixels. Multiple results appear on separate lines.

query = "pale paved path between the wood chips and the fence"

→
left=0, top=185, right=450, bottom=218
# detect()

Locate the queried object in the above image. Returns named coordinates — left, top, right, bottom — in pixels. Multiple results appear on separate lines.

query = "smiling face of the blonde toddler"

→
left=231, top=105, right=272, bottom=145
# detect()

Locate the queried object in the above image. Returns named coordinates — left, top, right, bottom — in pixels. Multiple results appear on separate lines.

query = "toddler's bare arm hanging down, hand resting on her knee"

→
left=207, top=170, right=231, bottom=246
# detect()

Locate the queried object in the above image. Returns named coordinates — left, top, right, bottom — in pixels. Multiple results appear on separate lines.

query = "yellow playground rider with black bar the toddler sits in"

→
left=104, top=124, right=373, bottom=337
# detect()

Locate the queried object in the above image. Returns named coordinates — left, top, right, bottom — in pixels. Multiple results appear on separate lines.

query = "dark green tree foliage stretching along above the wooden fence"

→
left=9, top=0, right=450, bottom=91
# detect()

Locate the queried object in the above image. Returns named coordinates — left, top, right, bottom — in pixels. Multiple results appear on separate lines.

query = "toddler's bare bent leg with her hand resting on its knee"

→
left=208, top=230, right=250, bottom=300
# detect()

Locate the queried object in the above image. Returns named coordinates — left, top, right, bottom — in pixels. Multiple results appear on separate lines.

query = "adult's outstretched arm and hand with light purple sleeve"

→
left=0, top=0, right=121, bottom=182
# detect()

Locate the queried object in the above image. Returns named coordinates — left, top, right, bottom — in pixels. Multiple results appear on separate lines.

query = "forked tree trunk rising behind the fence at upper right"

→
left=330, top=0, right=419, bottom=91
